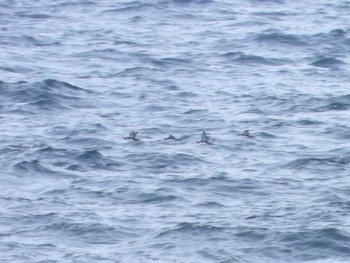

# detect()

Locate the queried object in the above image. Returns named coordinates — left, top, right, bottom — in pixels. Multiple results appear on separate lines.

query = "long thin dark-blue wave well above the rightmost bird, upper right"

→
left=222, top=52, right=290, bottom=66
